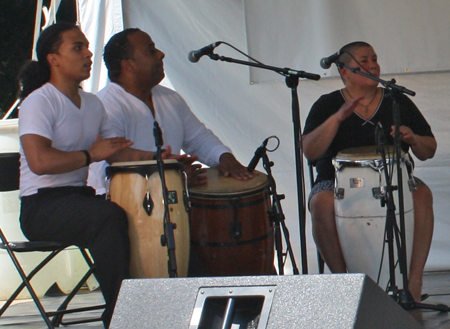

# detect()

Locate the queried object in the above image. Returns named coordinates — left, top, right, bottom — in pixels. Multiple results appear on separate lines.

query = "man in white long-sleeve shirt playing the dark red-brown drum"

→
left=88, top=29, right=252, bottom=194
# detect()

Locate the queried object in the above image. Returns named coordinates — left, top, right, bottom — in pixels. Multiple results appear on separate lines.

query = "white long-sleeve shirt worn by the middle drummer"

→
left=88, top=82, right=231, bottom=194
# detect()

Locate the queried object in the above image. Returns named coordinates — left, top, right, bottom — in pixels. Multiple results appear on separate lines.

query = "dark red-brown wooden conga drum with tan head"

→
left=189, top=168, right=274, bottom=276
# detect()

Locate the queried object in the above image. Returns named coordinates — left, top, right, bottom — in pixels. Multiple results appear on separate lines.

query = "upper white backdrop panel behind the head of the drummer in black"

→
left=244, top=0, right=450, bottom=82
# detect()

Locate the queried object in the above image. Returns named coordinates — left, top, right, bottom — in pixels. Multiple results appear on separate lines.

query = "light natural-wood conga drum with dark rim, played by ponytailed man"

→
left=106, top=160, right=190, bottom=278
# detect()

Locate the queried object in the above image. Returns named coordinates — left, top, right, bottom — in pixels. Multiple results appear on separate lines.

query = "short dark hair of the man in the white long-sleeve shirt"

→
left=103, top=28, right=140, bottom=82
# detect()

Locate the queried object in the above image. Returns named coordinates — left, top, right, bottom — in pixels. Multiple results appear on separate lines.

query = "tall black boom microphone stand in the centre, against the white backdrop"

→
left=208, top=53, right=320, bottom=274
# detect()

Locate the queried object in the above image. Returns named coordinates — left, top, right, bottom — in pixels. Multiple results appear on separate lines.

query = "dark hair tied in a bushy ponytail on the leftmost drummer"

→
left=17, top=22, right=78, bottom=98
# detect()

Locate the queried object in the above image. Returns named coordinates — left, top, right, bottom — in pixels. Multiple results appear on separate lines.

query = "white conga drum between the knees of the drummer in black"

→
left=333, top=146, right=414, bottom=289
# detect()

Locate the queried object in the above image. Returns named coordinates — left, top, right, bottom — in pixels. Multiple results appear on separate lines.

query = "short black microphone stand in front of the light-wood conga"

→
left=153, top=121, right=178, bottom=278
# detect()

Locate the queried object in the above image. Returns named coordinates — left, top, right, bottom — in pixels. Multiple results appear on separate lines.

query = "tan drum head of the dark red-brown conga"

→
left=189, top=168, right=268, bottom=196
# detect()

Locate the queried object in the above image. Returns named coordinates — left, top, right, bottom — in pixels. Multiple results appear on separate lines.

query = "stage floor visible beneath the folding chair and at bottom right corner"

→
left=0, top=272, right=450, bottom=329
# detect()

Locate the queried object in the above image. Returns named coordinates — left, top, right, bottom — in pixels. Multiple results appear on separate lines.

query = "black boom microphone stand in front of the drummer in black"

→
left=336, top=62, right=450, bottom=312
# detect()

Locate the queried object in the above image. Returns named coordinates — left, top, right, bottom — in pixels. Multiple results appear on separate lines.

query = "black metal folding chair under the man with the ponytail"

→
left=0, top=153, right=105, bottom=328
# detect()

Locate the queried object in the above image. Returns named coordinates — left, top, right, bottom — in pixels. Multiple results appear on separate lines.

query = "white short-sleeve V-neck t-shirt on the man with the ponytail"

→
left=19, top=83, right=115, bottom=196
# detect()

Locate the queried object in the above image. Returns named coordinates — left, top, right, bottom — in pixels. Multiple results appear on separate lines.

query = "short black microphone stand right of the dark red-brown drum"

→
left=262, top=144, right=299, bottom=275
